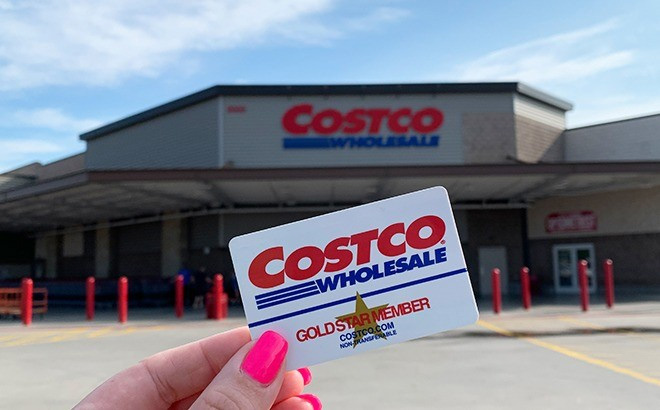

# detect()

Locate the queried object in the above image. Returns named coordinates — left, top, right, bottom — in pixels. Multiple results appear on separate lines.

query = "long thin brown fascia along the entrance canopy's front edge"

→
left=0, top=161, right=660, bottom=203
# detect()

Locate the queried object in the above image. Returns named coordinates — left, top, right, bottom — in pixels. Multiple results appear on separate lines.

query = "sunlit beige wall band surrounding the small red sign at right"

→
left=527, top=187, right=660, bottom=239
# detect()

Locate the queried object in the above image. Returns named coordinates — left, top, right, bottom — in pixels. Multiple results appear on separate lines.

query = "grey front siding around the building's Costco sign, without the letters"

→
left=223, top=93, right=513, bottom=167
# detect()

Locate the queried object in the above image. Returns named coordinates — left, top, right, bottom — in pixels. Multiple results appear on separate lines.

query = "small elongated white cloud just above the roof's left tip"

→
left=12, top=108, right=102, bottom=133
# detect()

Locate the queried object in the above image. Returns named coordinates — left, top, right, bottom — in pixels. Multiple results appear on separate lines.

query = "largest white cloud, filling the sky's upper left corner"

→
left=0, top=0, right=338, bottom=90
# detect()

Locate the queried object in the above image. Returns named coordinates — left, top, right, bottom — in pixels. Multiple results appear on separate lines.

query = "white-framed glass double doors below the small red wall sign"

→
left=552, top=243, right=596, bottom=294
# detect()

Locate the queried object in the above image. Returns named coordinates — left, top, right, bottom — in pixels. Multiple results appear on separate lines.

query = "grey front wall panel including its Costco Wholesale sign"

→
left=219, top=94, right=500, bottom=168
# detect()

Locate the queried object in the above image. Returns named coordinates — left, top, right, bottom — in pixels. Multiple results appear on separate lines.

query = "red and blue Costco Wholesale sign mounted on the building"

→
left=282, top=104, right=444, bottom=149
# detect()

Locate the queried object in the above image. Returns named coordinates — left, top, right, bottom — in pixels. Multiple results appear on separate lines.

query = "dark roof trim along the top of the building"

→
left=80, top=82, right=573, bottom=141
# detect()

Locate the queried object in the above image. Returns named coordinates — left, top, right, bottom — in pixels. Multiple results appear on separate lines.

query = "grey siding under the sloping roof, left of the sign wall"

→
left=86, top=99, right=219, bottom=169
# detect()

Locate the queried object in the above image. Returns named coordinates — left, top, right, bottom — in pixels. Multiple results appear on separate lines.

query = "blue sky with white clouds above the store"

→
left=0, top=0, right=660, bottom=172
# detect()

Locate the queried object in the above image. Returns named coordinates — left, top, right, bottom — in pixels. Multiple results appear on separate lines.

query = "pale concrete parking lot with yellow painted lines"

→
left=0, top=301, right=660, bottom=410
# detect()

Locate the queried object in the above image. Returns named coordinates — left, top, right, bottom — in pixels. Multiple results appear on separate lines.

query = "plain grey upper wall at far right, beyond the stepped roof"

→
left=565, top=115, right=660, bottom=162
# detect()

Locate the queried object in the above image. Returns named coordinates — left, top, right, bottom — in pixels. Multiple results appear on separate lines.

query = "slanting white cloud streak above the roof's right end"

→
left=456, top=20, right=635, bottom=84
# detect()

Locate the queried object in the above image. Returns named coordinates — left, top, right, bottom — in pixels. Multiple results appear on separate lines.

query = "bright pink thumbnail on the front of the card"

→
left=241, top=330, right=289, bottom=385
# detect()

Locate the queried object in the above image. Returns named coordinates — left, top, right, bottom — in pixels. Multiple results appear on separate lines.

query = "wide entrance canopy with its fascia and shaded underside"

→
left=0, top=162, right=660, bottom=232
